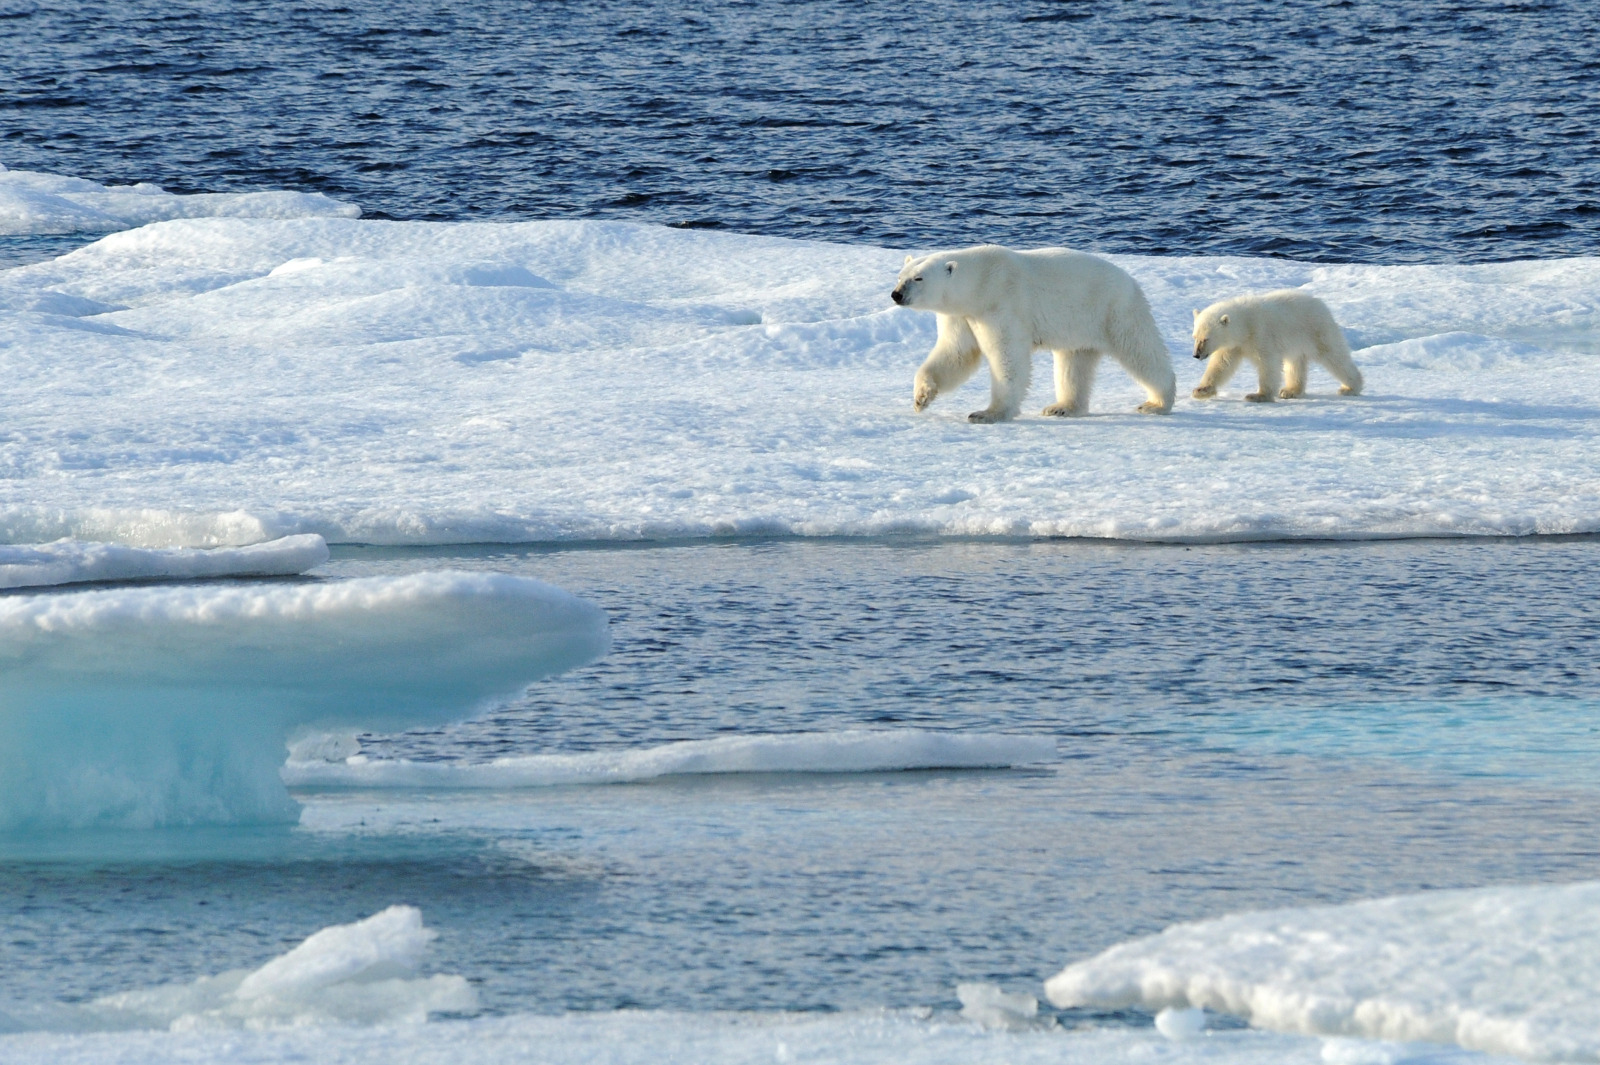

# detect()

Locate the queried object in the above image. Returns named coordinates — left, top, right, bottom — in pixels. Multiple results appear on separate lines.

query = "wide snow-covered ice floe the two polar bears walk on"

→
left=0, top=184, right=1600, bottom=547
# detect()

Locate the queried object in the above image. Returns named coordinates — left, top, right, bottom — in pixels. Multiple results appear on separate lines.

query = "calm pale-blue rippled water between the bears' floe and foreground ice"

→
left=9, top=539, right=1600, bottom=1020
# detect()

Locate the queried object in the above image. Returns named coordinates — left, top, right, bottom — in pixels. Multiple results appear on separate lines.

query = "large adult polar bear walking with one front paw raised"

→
left=891, top=245, right=1178, bottom=422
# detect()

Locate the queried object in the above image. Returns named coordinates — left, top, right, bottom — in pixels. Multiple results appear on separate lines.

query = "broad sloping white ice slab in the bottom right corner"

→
left=1045, top=883, right=1600, bottom=1062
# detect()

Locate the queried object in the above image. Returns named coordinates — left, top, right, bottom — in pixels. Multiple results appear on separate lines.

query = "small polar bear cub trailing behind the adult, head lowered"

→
left=1194, top=288, right=1362, bottom=403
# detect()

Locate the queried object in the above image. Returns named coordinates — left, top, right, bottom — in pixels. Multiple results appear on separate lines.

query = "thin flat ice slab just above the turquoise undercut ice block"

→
left=0, top=534, right=328, bottom=588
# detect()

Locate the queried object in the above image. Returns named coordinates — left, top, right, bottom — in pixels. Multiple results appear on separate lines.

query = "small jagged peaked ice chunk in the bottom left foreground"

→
left=46, top=907, right=478, bottom=1031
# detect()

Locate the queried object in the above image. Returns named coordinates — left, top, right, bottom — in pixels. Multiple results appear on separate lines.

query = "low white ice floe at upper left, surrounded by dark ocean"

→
left=0, top=168, right=362, bottom=233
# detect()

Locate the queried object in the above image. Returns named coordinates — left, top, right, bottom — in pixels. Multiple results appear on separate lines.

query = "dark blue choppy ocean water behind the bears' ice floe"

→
left=0, top=0, right=1600, bottom=262
